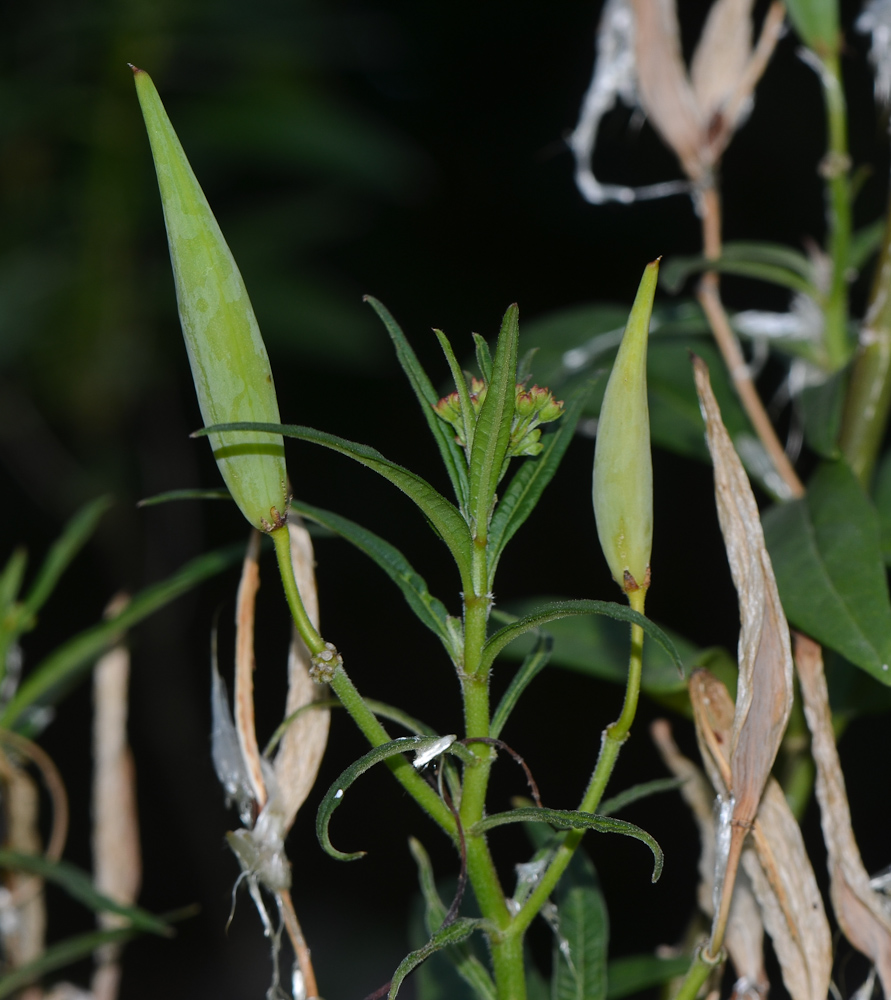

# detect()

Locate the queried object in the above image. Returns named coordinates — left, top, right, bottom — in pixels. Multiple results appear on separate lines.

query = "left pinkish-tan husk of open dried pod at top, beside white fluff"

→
left=631, top=0, right=705, bottom=180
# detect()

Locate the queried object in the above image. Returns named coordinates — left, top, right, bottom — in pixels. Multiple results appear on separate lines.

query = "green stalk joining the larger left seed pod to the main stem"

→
left=270, top=527, right=458, bottom=840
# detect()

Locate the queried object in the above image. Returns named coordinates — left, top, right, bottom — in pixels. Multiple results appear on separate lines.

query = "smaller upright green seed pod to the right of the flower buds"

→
left=594, top=260, right=659, bottom=594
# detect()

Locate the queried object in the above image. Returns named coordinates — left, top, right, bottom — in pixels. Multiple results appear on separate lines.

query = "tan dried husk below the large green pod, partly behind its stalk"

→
left=275, top=512, right=331, bottom=831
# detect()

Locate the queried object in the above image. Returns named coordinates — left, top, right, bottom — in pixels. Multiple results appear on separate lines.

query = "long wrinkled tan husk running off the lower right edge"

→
left=795, top=635, right=891, bottom=997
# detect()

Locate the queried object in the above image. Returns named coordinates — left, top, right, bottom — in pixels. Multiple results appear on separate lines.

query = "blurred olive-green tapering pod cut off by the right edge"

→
left=839, top=207, right=891, bottom=489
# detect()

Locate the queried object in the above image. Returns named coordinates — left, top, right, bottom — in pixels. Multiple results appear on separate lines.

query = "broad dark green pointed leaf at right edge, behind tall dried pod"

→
left=762, top=462, right=891, bottom=684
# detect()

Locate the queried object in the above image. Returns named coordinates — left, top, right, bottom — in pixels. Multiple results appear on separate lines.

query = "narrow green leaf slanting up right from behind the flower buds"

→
left=488, top=382, right=592, bottom=589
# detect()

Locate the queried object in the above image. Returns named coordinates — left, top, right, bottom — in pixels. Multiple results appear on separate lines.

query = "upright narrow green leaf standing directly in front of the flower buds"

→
left=468, top=305, right=520, bottom=539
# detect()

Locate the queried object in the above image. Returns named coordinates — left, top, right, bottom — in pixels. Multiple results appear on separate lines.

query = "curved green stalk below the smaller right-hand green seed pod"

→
left=508, top=590, right=646, bottom=936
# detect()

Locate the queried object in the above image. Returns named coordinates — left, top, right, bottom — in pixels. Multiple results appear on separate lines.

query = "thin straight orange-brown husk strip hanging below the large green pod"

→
left=235, top=531, right=266, bottom=809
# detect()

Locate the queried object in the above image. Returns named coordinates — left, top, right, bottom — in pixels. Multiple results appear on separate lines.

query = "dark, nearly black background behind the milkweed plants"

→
left=0, top=0, right=888, bottom=1000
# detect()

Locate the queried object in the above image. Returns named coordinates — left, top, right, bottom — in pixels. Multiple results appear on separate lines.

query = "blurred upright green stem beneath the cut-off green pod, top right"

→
left=819, top=53, right=851, bottom=371
